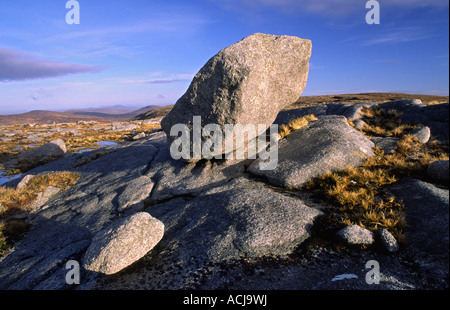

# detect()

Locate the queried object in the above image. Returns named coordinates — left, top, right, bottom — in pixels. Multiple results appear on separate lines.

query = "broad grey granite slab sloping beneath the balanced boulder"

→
left=0, top=133, right=321, bottom=289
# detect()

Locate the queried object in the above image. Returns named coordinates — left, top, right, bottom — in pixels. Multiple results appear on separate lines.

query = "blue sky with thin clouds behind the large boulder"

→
left=0, top=0, right=449, bottom=114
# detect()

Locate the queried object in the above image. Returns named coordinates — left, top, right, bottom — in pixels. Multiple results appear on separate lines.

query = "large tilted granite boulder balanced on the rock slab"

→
left=161, top=33, right=312, bottom=161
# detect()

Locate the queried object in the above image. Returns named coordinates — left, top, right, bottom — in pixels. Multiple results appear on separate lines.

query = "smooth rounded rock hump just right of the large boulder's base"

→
left=249, top=116, right=374, bottom=188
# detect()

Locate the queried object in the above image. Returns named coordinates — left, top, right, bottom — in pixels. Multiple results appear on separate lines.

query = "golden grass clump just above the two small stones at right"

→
left=306, top=152, right=406, bottom=239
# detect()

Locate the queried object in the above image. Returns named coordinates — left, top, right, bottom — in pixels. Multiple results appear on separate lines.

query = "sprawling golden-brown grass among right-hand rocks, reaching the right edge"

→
left=305, top=109, right=449, bottom=242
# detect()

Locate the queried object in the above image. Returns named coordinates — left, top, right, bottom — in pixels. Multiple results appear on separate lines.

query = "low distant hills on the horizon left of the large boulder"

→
left=0, top=105, right=161, bottom=125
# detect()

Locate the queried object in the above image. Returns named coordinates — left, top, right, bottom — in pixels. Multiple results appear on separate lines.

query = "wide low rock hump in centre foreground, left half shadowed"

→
left=148, top=178, right=321, bottom=262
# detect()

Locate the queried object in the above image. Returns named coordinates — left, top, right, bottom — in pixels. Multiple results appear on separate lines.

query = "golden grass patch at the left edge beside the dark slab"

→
left=0, top=172, right=80, bottom=257
